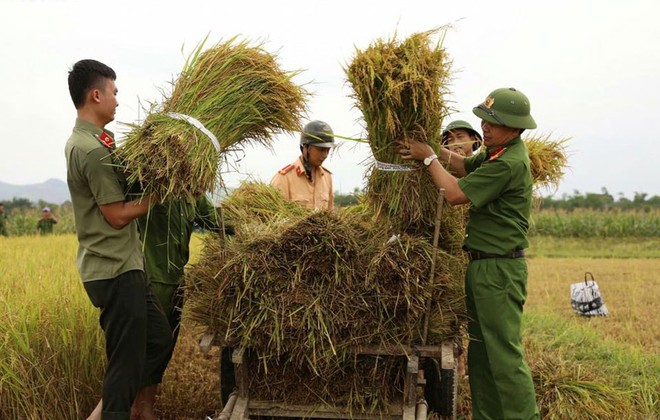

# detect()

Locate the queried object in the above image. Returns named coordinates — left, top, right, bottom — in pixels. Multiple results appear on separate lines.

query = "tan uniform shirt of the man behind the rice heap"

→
left=270, top=156, right=334, bottom=210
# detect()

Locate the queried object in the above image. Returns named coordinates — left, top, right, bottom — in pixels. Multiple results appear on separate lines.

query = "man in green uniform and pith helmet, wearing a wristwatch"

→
left=400, top=88, right=539, bottom=420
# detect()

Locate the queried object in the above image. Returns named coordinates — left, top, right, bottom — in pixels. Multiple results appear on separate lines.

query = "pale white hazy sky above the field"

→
left=0, top=0, right=660, bottom=196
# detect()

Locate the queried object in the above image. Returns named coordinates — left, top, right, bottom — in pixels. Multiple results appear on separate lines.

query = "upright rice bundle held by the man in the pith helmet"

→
left=345, top=30, right=450, bottom=231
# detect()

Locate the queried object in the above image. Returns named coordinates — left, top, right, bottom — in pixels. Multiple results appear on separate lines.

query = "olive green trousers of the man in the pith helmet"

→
left=465, top=258, right=539, bottom=420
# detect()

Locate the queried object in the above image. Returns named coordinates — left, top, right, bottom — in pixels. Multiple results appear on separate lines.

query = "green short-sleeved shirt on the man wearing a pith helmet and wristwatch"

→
left=458, top=137, right=532, bottom=255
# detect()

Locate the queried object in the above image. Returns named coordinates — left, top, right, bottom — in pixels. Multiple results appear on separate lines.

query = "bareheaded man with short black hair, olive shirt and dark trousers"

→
left=65, top=60, right=172, bottom=420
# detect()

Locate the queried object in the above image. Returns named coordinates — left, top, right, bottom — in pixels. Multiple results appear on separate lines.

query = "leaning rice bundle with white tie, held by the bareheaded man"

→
left=118, top=38, right=307, bottom=202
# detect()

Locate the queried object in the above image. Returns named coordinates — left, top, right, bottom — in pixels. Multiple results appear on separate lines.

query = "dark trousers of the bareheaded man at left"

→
left=84, top=270, right=172, bottom=420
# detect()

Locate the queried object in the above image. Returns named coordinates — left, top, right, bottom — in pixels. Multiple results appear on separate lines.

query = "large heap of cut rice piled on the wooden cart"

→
left=187, top=184, right=464, bottom=410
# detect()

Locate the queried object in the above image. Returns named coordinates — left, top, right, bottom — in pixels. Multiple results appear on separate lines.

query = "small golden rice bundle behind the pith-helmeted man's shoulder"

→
left=524, top=135, right=569, bottom=189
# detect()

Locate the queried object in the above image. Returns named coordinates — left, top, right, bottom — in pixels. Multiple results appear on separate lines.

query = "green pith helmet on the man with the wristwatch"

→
left=472, top=88, right=536, bottom=129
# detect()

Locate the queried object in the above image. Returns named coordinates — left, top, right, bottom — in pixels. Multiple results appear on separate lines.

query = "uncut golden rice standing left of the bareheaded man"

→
left=0, top=235, right=105, bottom=419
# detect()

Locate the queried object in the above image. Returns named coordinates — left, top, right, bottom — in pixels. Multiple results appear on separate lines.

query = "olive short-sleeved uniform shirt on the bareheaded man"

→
left=65, top=118, right=144, bottom=281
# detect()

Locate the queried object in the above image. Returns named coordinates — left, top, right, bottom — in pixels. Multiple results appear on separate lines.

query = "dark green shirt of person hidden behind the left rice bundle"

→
left=138, top=197, right=218, bottom=285
